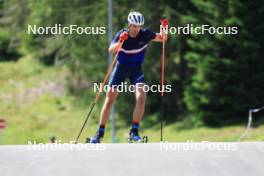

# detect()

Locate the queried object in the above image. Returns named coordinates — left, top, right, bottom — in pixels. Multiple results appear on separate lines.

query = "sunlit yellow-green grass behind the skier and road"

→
left=0, top=57, right=264, bottom=144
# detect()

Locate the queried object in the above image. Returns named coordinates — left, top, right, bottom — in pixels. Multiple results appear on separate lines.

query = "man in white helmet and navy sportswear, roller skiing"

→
left=90, top=12, right=167, bottom=143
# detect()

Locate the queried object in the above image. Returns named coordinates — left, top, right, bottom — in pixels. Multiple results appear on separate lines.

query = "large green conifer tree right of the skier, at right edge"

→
left=184, top=0, right=264, bottom=125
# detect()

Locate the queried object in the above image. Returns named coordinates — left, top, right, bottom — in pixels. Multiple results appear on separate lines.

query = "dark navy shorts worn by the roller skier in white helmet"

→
left=108, top=62, right=145, bottom=86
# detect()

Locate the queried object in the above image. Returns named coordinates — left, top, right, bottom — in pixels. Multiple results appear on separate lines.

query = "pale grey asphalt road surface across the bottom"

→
left=0, top=142, right=264, bottom=176
